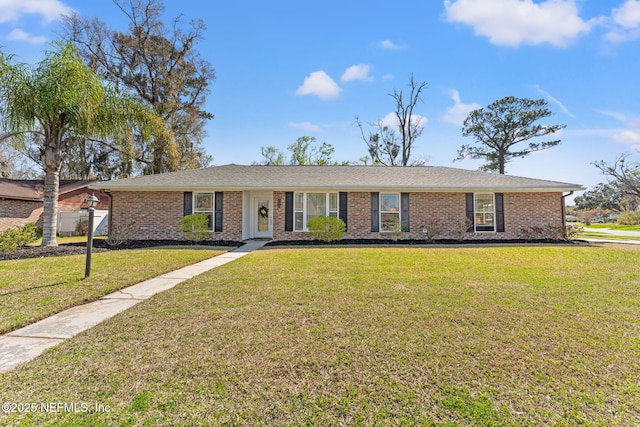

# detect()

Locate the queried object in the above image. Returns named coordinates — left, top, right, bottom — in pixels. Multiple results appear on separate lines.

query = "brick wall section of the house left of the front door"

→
left=111, top=191, right=242, bottom=241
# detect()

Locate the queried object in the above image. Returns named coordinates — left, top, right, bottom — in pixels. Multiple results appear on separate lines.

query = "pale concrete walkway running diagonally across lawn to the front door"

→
left=0, top=240, right=267, bottom=372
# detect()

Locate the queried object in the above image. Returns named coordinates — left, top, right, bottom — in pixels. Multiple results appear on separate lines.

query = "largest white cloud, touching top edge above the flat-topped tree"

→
left=444, top=0, right=594, bottom=47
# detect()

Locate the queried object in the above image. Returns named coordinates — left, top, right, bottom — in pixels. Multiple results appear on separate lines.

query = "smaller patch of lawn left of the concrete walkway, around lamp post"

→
left=0, top=248, right=222, bottom=333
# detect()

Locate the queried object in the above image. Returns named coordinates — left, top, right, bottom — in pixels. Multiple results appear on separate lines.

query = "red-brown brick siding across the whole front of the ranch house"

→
left=111, top=191, right=563, bottom=241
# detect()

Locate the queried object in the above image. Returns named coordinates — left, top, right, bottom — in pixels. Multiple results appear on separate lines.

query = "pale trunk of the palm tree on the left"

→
left=41, top=143, right=62, bottom=246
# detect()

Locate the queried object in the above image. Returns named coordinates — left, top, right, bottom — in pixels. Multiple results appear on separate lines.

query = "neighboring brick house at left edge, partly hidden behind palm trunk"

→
left=0, top=178, right=109, bottom=232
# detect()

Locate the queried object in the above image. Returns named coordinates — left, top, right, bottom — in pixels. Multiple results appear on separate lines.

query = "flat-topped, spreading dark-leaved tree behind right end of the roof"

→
left=455, top=96, right=566, bottom=174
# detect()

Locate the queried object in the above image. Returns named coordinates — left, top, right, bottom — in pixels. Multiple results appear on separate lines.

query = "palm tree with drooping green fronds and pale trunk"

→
left=0, top=41, right=168, bottom=246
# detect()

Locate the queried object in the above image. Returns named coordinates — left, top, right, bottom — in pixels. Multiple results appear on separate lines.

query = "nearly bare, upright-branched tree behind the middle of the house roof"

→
left=356, top=74, right=427, bottom=166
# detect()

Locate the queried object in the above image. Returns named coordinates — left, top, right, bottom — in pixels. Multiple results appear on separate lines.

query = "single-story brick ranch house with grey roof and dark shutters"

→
left=90, top=164, right=585, bottom=241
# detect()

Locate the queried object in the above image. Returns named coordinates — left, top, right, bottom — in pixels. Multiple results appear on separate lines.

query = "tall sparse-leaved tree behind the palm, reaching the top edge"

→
left=63, top=0, right=215, bottom=175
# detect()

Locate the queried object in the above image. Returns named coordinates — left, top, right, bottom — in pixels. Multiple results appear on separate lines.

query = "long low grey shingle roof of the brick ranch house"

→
left=90, top=164, right=585, bottom=192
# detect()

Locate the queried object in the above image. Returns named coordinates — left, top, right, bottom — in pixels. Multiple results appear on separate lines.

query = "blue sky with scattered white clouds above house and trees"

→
left=0, top=0, right=640, bottom=199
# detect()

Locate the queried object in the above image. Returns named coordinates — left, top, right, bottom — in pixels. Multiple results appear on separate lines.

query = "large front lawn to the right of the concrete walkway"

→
left=0, top=246, right=640, bottom=426
